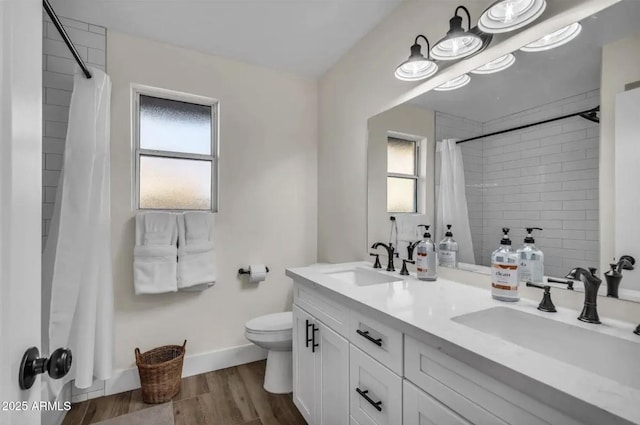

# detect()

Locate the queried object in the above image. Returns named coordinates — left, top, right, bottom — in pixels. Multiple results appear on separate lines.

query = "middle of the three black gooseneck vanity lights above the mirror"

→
left=431, top=6, right=484, bottom=60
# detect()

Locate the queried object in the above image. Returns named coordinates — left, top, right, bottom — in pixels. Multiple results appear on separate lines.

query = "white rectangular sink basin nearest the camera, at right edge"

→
left=451, top=307, right=640, bottom=389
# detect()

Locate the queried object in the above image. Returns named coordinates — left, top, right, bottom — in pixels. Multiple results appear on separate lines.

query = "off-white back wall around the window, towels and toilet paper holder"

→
left=107, top=31, right=317, bottom=369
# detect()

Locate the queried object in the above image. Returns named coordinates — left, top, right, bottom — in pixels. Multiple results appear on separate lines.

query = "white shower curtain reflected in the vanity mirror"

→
left=435, top=139, right=475, bottom=264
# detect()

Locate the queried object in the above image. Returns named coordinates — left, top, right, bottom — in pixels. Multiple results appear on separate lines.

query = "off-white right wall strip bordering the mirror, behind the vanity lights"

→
left=318, top=0, right=618, bottom=262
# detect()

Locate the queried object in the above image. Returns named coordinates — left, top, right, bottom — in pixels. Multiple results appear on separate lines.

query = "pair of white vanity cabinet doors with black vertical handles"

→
left=293, top=306, right=349, bottom=425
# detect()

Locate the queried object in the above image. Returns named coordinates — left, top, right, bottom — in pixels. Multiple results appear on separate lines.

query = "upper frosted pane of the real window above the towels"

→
left=139, top=95, right=212, bottom=155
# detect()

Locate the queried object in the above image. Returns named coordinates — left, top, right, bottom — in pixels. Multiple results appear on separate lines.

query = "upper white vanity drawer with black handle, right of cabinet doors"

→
left=349, top=310, right=403, bottom=376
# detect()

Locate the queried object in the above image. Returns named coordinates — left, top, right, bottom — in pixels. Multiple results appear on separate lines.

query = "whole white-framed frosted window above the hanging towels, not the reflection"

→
left=133, top=87, right=218, bottom=211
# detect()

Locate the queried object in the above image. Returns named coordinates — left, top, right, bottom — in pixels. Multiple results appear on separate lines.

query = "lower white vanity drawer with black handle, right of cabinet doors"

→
left=349, top=345, right=402, bottom=425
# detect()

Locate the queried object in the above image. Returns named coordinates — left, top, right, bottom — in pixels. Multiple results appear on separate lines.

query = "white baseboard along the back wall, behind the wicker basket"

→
left=104, top=344, right=267, bottom=395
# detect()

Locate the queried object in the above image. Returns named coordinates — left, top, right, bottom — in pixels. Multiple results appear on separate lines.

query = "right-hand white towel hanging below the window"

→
left=178, top=212, right=216, bottom=291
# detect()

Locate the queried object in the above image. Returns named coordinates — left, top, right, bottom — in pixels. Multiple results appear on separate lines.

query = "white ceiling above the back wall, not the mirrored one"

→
left=51, top=0, right=402, bottom=78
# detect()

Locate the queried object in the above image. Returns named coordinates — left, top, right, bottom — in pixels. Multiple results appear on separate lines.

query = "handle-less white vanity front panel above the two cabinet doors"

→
left=293, top=282, right=349, bottom=338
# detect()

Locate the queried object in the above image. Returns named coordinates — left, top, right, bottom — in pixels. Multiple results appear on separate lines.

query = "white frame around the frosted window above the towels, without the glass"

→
left=131, top=84, right=220, bottom=212
